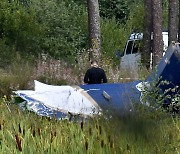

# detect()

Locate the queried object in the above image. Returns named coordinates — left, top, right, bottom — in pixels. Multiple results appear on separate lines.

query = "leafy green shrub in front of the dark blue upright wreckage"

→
left=141, top=76, right=180, bottom=114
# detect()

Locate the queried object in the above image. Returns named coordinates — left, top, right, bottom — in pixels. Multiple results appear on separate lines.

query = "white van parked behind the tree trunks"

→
left=120, top=32, right=168, bottom=72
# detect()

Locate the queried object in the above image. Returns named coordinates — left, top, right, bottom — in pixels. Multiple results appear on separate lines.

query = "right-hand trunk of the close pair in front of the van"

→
left=153, top=0, right=163, bottom=66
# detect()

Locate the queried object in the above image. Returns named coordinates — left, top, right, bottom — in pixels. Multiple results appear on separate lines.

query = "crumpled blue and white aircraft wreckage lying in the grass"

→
left=14, top=43, right=180, bottom=119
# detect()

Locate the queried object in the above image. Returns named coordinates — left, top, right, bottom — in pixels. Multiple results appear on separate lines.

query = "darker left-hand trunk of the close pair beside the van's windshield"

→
left=142, top=0, right=153, bottom=69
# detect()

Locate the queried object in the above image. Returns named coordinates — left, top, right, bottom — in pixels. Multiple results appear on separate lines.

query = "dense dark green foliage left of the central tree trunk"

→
left=0, top=0, right=87, bottom=62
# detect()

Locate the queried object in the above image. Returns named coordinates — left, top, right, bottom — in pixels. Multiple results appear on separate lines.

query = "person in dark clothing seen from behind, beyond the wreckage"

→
left=84, top=60, right=107, bottom=84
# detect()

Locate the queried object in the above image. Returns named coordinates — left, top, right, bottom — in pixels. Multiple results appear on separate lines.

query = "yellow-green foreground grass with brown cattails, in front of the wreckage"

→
left=0, top=98, right=180, bottom=154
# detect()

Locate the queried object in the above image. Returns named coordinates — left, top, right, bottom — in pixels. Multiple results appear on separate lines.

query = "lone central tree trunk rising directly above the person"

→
left=87, top=0, right=101, bottom=61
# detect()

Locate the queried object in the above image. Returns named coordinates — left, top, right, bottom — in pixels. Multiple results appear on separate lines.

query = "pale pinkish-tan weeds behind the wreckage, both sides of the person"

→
left=0, top=50, right=147, bottom=96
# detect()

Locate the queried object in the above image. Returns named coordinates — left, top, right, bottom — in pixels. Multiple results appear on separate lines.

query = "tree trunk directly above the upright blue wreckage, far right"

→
left=168, top=0, right=178, bottom=45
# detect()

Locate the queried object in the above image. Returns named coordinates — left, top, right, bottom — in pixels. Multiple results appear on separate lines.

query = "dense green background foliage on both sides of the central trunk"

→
left=0, top=0, right=146, bottom=67
